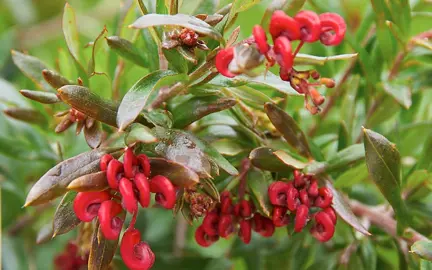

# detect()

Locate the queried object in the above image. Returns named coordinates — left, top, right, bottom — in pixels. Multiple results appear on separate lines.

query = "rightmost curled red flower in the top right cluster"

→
left=319, top=13, right=346, bottom=46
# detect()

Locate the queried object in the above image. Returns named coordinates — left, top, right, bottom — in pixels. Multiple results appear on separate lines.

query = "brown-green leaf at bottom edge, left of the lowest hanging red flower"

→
left=88, top=222, right=118, bottom=270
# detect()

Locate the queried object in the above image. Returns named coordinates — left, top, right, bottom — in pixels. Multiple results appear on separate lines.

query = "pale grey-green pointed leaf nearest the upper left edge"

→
left=11, top=50, right=52, bottom=91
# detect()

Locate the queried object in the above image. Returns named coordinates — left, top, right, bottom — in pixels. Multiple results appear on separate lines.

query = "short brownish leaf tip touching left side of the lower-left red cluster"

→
left=67, top=171, right=108, bottom=192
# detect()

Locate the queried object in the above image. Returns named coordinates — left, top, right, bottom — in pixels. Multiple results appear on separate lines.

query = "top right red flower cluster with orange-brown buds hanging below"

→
left=215, top=10, right=346, bottom=114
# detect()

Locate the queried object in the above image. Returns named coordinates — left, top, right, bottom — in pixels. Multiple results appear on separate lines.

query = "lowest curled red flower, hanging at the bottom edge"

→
left=120, top=229, right=155, bottom=270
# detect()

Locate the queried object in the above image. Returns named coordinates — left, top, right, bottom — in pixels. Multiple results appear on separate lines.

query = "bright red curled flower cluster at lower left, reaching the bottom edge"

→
left=73, top=148, right=176, bottom=269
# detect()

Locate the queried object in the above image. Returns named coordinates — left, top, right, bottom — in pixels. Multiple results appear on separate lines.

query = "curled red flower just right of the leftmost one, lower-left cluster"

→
left=98, top=200, right=123, bottom=240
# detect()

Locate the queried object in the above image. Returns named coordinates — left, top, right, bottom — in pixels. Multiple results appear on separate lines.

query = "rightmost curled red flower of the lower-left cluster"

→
left=150, top=175, right=176, bottom=209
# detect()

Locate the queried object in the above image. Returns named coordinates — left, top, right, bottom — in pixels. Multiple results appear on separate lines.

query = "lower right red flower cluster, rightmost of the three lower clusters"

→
left=268, top=171, right=337, bottom=242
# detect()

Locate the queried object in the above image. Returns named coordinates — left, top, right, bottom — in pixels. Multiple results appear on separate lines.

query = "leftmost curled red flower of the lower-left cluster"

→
left=73, top=191, right=111, bottom=222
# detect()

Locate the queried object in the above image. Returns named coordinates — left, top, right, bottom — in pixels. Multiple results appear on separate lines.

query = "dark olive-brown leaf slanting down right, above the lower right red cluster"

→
left=264, top=103, right=312, bottom=158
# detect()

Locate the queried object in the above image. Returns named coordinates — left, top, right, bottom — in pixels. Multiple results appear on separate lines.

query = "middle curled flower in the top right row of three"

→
left=294, top=10, right=321, bottom=42
